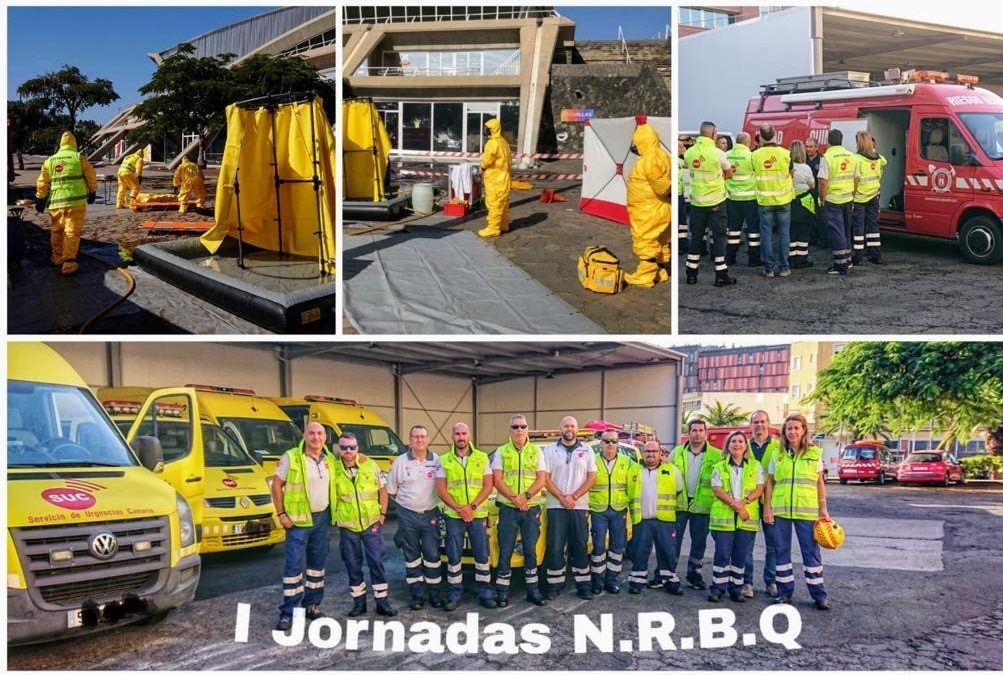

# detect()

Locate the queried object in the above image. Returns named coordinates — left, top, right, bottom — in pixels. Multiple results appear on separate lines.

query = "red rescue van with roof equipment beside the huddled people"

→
left=743, top=70, right=1003, bottom=265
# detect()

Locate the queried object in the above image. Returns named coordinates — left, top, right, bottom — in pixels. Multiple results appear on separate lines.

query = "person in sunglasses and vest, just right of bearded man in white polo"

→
left=589, top=431, right=634, bottom=596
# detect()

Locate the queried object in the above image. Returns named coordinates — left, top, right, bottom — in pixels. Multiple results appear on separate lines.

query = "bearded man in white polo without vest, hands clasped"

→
left=544, top=415, right=597, bottom=600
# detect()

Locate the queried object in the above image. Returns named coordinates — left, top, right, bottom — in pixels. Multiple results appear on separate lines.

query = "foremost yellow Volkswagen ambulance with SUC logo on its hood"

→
left=7, top=342, right=201, bottom=645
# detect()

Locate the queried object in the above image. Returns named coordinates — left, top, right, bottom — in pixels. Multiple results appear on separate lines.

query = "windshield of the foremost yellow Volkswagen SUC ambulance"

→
left=7, top=380, right=138, bottom=467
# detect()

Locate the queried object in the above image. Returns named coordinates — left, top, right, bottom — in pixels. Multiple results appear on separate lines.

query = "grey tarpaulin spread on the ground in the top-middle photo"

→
left=343, top=228, right=605, bottom=335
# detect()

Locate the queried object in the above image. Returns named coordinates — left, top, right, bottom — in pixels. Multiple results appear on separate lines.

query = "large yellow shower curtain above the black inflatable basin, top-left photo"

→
left=200, top=97, right=335, bottom=274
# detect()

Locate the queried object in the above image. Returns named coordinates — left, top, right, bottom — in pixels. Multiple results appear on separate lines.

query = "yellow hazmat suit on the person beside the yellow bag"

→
left=624, top=124, right=671, bottom=288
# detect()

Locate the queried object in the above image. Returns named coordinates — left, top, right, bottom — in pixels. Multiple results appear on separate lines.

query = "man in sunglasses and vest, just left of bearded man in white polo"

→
left=491, top=415, right=547, bottom=607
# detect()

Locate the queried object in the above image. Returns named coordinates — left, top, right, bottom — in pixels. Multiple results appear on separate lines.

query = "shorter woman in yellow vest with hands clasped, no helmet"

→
left=707, top=430, right=763, bottom=603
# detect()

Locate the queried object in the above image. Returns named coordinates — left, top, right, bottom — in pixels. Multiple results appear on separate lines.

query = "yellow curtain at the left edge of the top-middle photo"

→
left=341, top=98, right=390, bottom=202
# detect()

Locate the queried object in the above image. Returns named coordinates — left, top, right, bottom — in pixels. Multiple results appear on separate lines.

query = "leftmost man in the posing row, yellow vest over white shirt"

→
left=272, top=422, right=337, bottom=632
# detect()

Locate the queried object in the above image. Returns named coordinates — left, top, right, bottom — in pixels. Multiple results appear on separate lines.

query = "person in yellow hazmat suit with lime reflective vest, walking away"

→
left=35, top=131, right=97, bottom=275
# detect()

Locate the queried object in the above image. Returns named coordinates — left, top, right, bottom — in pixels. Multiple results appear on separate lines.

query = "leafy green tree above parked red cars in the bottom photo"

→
left=808, top=342, right=1003, bottom=443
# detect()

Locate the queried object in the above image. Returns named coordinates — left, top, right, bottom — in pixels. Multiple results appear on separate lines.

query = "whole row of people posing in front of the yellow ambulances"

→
left=272, top=410, right=828, bottom=631
